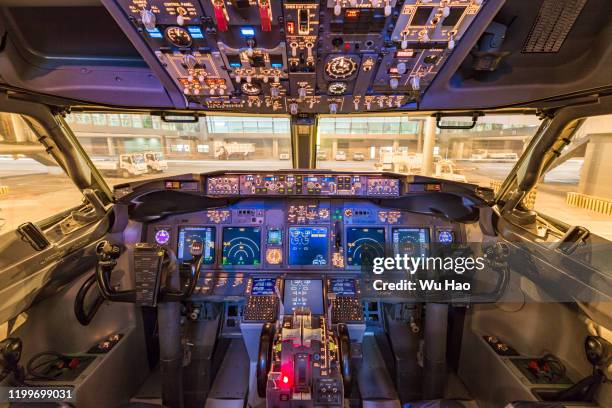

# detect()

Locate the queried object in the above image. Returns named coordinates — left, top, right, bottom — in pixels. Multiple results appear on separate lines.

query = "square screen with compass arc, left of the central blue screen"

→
left=222, top=227, right=261, bottom=266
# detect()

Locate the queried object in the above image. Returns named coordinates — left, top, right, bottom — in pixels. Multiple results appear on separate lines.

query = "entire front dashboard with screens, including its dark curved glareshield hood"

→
left=114, top=169, right=488, bottom=322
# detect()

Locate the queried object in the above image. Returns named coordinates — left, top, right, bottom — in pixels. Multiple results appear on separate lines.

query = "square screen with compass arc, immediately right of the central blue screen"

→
left=346, top=228, right=385, bottom=266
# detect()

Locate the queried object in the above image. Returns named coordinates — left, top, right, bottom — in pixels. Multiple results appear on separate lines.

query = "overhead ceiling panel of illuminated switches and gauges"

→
left=104, top=0, right=485, bottom=115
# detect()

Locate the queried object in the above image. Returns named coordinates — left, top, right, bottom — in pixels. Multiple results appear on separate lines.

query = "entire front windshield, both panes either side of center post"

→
left=67, top=112, right=539, bottom=188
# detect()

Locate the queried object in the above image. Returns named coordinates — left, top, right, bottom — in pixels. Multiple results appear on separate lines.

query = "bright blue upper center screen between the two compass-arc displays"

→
left=289, top=227, right=329, bottom=266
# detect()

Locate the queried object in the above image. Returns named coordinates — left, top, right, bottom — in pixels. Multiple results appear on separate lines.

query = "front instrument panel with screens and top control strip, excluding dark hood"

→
left=145, top=172, right=465, bottom=322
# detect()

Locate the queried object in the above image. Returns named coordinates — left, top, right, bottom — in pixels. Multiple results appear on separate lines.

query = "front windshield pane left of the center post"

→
left=66, top=112, right=292, bottom=186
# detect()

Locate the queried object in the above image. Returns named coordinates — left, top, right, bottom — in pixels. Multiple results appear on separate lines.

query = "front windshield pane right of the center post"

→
left=317, top=114, right=540, bottom=189
